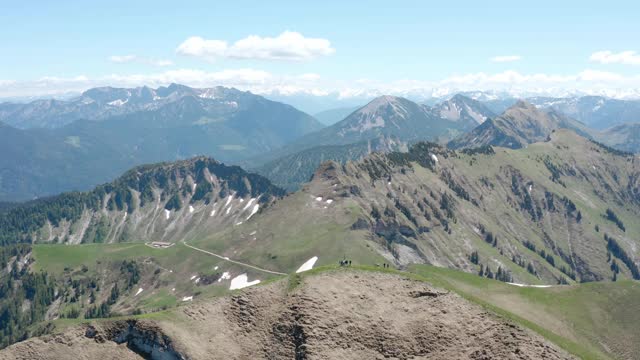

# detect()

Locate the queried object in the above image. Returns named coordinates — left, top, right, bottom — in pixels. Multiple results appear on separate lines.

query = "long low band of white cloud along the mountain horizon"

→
left=0, top=68, right=640, bottom=99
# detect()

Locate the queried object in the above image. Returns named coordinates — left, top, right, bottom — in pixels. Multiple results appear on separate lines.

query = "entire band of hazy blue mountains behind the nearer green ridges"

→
left=0, top=84, right=640, bottom=201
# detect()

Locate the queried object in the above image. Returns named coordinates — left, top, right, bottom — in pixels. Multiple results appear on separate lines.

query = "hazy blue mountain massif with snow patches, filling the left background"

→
left=0, top=85, right=323, bottom=201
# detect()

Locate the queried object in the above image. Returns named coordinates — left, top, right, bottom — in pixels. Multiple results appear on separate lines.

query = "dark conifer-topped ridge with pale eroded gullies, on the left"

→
left=0, top=157, right=284, bottom=248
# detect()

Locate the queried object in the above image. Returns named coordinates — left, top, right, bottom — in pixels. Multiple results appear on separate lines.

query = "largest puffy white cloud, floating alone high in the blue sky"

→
left=176, top=31, right=335, bottom=61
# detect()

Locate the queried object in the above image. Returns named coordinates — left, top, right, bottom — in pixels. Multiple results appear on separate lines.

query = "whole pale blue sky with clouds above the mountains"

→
left=0, top=0, right=640, bottom=96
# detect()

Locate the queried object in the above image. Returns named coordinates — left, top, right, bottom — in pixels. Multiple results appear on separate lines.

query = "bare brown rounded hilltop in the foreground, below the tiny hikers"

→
left=0, top=270, right=573, bottom=359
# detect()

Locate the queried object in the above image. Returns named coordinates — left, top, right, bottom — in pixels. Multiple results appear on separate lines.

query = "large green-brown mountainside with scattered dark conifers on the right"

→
left=272, top=130, right=640, bottom=283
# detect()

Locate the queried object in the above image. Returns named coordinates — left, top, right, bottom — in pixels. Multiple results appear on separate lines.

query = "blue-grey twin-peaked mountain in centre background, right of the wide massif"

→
left=249, top=95, right=495, bottom=190
